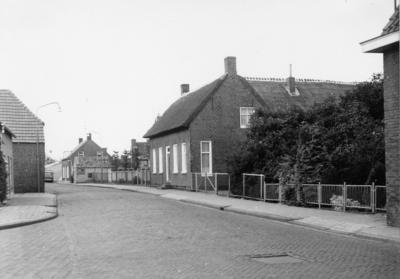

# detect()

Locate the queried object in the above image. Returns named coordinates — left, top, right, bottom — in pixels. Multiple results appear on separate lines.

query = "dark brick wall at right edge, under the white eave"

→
left=383, top=44, right=400, bottom=227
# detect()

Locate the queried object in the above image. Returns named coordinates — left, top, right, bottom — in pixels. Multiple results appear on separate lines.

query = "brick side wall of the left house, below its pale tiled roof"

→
left=13, top=142, right=45, bottom=193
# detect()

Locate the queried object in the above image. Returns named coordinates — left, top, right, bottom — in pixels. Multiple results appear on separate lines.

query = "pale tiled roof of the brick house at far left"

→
left=0, top=90, right=44, bottom=143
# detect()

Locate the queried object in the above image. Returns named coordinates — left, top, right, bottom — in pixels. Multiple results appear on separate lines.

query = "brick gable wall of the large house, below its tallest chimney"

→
left=190, top=75, right=261, bottom=173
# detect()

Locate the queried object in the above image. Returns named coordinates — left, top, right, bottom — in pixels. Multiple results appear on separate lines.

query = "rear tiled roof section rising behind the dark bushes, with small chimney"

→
left=245, top=78, right=356, bottom=109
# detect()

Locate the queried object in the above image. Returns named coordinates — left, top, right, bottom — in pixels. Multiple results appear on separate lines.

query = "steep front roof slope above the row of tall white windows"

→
left=143, top=75, right=226, bottom=138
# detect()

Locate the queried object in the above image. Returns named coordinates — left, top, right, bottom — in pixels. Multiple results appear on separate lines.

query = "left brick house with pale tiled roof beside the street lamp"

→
left=0, top=90, right=45, bottom=193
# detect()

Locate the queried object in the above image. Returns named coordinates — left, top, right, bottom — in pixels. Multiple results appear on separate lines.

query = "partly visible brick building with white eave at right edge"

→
left=361, top=6, right=400, bottom=227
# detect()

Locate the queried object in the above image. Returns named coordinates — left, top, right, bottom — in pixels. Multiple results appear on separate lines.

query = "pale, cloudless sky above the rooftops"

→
left=0, top=0, right=394, bottom=160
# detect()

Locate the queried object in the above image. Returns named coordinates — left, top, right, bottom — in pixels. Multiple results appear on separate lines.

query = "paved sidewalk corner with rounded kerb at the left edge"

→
left=0, top=193, right=57, bottom=230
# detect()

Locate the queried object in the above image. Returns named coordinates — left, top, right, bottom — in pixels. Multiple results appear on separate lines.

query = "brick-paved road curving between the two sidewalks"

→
left=0, top=184, right=400, bottom=279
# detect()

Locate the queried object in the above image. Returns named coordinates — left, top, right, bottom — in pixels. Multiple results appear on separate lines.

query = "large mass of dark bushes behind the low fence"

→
left=227, top=74, right=385, bottom=205
